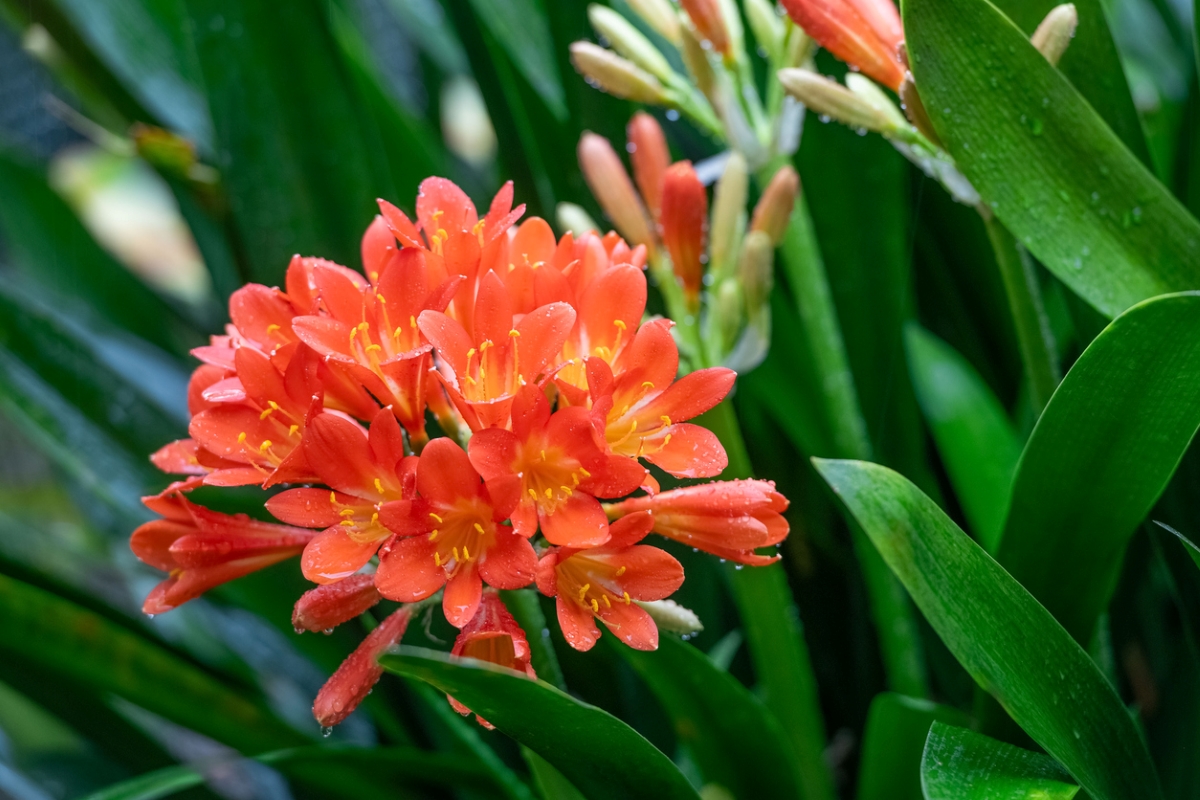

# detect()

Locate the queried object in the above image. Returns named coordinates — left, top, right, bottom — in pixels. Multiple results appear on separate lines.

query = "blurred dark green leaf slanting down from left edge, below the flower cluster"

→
left=0, top=576, right=305, bottom=752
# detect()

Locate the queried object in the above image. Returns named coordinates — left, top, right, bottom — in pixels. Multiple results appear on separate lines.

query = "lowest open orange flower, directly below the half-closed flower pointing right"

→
left=538, top=513, right=683, bottom=650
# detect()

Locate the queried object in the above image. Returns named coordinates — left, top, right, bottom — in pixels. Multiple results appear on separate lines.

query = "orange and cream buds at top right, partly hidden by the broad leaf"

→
left=778, top=0, right=1078, bottom=205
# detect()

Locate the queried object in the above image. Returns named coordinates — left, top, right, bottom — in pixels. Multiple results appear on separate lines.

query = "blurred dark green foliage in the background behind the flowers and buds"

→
left=0, top=0, right=1200, bottom=800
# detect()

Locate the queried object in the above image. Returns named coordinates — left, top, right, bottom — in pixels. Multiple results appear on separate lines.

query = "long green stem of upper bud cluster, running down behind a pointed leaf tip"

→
left=758, top=157, right=929, bottom=697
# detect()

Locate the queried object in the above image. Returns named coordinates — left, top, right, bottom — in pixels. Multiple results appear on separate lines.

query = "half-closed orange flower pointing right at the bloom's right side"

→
left=608, top=481, right=788, bottom=566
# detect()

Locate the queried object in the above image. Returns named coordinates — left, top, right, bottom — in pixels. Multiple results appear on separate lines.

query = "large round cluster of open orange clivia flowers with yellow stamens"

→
left=131, top=178, right=788, bottom=726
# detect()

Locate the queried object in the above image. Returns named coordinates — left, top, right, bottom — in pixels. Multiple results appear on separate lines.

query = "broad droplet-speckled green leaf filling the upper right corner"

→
left=905, top=0, right=1200, bottom=317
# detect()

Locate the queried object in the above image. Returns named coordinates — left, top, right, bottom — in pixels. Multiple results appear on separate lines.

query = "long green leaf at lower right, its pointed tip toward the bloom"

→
left=814, top=459, right=1162, bottom=800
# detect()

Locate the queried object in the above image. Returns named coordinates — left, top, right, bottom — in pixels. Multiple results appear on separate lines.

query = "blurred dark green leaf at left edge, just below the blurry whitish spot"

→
left=0, top=149, right=199, bottom=355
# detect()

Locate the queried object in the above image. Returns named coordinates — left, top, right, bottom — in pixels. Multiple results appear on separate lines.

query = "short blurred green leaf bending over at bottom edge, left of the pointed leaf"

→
left=854, top=692, right=967, bottom=800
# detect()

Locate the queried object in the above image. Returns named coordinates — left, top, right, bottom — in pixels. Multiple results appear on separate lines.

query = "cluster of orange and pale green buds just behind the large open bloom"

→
left=564, top=112, right=799, bottom=371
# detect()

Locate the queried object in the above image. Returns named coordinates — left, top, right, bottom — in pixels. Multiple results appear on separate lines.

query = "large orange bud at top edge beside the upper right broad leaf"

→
left=782, top=0, right=904, bottom=91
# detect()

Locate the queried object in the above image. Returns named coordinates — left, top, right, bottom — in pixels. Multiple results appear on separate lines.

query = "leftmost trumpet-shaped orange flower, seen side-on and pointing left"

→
left=130, top=479, right=313, bottom=614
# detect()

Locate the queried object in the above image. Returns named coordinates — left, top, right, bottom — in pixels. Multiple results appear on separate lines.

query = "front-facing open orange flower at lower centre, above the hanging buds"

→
left=376, top=439, right=536, bottom=627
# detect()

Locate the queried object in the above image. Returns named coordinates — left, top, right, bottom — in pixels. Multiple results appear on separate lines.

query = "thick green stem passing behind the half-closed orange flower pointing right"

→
left=702, top=401, right=835, bottom=800
